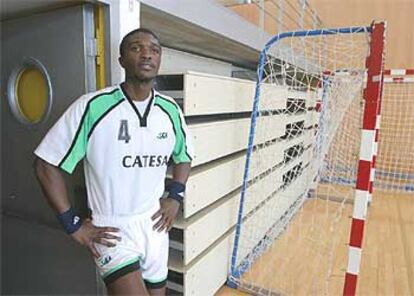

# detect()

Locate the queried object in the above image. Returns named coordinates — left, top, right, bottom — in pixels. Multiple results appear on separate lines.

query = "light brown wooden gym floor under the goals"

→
left=216, top=192, right=414, bottom=296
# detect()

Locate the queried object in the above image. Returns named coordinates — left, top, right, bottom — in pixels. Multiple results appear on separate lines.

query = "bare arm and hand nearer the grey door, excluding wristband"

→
left=34, top=157, right=120, bottom=258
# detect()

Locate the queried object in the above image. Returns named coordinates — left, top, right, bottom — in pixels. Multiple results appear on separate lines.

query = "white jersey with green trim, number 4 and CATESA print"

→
left=35, top=86, right=193, bottom=216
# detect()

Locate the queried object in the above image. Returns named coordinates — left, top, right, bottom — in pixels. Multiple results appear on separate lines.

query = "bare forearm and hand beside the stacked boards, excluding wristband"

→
left=152, top=162, right=191, bottom=232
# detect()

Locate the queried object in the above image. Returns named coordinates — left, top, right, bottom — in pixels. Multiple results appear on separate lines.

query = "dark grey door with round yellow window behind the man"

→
left=1, top=5, right=98, bottom=295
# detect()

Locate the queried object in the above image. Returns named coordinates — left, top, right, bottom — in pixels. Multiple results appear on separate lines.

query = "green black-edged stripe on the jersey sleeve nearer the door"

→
left=59, top=89, right=125, bottom=174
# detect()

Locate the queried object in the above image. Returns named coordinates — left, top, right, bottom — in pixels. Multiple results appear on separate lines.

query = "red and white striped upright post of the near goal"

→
left=344, top=23, right=385, bottom=295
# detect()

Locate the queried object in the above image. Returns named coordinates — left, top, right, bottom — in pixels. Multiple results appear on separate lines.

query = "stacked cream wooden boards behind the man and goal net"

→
left=157, top=72, right=318, bottom=295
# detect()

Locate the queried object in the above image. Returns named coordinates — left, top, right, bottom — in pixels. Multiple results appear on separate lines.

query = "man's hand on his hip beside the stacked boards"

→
left=151, top=198, right=180, bottom=232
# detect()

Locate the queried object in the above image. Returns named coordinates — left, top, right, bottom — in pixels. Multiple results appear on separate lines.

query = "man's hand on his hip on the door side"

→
left=71, top=219, right=121, bottom=258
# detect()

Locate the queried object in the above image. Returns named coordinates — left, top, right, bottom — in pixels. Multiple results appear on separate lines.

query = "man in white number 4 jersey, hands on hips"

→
left=35, top=29, right=192, bottom=295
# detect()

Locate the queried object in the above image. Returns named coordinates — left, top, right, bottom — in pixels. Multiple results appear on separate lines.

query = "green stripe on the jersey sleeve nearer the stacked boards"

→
left=154, top=95, right=192, bottom=163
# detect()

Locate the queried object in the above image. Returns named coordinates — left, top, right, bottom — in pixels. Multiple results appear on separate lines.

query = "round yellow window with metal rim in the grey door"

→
left=8, top=58, right=52, bottom=125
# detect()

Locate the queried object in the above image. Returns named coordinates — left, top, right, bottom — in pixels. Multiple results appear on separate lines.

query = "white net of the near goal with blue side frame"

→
left=230, top=29, right=369, bottom=295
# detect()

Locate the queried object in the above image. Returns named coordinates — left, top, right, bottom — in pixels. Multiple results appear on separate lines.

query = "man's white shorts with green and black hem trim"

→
left=92, top=202, right=168, bottom=289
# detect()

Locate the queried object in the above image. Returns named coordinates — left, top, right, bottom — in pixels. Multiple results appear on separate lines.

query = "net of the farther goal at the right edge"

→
left=374, top=76, right=414, bottom=194
